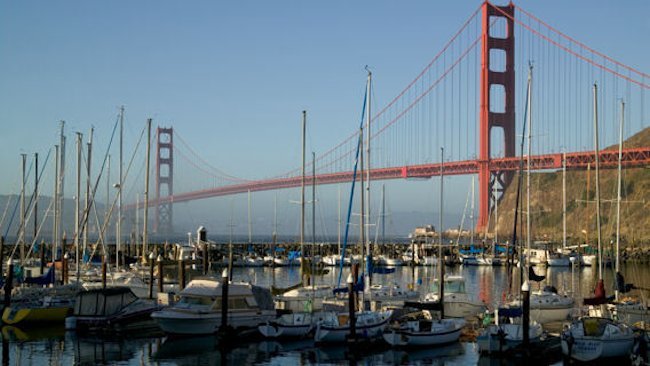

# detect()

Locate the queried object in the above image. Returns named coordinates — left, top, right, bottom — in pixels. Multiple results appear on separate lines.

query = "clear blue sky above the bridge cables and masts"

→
left=0, top=0, right=650, bottom=237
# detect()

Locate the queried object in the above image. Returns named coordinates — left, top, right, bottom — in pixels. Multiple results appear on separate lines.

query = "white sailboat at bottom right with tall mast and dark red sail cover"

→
left=562, top=84, right=634, bottom=362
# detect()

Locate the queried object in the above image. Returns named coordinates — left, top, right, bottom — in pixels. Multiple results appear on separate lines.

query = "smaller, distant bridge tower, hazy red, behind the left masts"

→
left=154, top=127, right=174, bottom=234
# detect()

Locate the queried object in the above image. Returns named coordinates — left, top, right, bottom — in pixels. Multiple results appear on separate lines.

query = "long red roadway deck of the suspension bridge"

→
left=139, top=147, right=650, bottom=209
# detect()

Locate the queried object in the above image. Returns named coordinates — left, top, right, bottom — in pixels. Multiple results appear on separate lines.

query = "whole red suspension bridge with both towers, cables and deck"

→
left=138, top=2, right=650, bottom=232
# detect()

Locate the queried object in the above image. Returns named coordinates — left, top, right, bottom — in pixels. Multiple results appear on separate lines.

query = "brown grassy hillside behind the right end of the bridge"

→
left=498, top=128, right=650, bottom=244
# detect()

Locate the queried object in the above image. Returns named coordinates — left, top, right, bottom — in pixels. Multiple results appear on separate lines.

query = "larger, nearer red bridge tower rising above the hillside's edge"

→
left=477, top=1, right=515, bottom=229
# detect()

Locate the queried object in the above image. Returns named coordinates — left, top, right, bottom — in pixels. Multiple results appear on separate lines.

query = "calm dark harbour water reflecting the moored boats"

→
left=2, top=264, right=650, bottom=366
